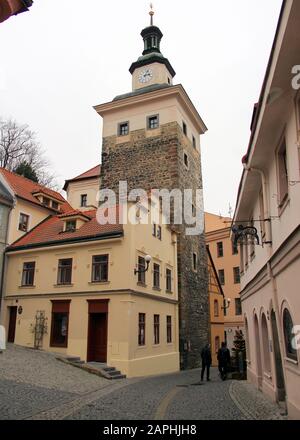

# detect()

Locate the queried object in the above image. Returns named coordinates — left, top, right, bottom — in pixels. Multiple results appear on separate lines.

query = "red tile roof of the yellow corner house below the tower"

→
left=7, top=208, right=123, bottom=251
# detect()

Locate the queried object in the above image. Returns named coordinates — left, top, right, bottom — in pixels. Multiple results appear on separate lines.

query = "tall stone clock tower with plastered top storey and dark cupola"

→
left=95, top=11, right=209, bottom=368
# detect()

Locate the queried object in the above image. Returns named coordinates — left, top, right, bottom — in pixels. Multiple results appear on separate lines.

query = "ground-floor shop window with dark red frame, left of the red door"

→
left=50, top=301, right=70, bottom=347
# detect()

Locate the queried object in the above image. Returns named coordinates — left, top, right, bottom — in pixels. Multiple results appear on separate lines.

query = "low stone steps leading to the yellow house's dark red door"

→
left=56, top=356, right=126, bottom=380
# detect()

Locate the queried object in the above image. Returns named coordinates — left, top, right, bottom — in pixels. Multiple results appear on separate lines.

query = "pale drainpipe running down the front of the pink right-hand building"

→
left=243, top=164, right=287, bottom=410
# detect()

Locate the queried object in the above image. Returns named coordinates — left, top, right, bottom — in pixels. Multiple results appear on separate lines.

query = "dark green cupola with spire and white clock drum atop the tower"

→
left=129, top=5, right=176, bottom=90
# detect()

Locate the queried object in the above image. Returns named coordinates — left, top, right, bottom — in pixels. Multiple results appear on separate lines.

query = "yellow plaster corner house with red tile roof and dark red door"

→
left=2, top=203, right=179, bottom=377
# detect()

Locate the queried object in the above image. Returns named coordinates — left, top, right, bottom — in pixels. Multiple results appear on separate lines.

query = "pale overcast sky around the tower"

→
left=0, top=0, right=282, bottom=215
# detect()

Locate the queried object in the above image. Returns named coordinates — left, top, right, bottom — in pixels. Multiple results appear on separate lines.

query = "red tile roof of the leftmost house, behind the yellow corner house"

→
left=0, top=167, right=72, bottom=212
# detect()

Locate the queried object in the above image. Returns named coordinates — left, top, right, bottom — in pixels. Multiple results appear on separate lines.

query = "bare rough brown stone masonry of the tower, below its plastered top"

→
left=101, top=122, right=209, bottom=368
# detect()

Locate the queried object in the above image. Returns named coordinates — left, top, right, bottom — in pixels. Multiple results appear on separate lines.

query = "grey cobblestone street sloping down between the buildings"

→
left=0, top=346, right=285, bottom=420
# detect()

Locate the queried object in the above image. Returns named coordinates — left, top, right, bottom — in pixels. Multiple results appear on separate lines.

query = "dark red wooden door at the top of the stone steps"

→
left=87, top=313, right=107, bottom=363
